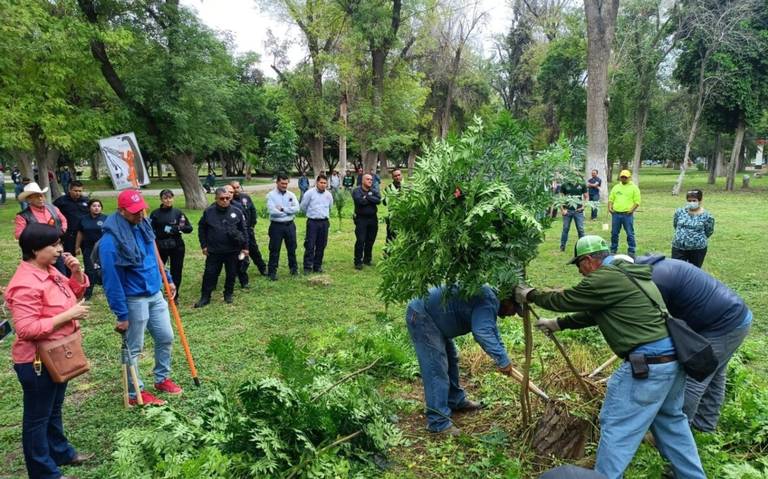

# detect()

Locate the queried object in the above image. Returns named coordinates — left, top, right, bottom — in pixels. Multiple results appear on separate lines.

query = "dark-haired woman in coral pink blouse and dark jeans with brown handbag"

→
left=5, top=223, right=90, bottom=479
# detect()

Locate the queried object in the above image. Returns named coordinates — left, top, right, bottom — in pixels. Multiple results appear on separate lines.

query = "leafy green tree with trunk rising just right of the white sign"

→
left=78, top=0, right=237, bottom=209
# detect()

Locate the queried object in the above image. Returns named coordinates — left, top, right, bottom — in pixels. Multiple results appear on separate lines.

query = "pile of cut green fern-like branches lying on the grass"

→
left=114, top=337, right=403, bottom=478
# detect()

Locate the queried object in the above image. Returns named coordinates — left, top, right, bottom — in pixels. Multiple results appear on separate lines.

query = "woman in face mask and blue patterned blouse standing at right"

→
left=672, top=190, right=715, bottom=268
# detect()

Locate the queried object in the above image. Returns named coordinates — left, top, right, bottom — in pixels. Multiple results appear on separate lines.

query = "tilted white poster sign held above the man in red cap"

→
left=99, top=132, right=149, bottom=191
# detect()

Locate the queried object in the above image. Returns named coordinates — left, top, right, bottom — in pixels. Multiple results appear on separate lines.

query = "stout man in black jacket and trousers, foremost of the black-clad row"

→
left=195, top=187, right=248, bottom=308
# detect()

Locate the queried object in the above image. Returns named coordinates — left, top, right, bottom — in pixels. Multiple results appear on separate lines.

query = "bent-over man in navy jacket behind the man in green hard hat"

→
left=637, top=255, right=752, bottom=432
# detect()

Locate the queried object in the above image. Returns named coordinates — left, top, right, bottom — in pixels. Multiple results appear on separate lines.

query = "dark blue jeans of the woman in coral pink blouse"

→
left=13, top=363, right=77, bottom=479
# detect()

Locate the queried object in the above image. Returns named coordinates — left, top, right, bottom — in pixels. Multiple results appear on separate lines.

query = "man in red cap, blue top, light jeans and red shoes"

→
left=98, top=190, right=182, bottom=405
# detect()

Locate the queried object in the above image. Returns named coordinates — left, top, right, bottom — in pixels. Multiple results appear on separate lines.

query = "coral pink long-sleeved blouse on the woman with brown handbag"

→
left=5, top=261, right=90, bottom=364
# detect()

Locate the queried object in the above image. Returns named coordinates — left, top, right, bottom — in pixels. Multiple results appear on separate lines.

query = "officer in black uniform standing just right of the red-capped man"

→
left=149, top=189, right=192, bottom=304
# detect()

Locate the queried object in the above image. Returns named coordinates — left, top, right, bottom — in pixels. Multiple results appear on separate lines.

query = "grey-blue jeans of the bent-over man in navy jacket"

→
left=683, top=313, right=751, bottom=432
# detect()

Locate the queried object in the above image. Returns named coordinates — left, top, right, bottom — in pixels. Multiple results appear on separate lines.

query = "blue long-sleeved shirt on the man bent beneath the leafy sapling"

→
left=409, top=286, right=509, bottom=368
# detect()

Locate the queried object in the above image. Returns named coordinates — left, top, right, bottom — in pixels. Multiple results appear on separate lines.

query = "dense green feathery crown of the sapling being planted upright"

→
left=380, top=116, right=575, bottom=303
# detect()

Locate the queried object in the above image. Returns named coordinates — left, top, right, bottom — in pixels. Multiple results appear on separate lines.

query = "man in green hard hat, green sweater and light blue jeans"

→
left=515, top=235, right=706, bottom=479
